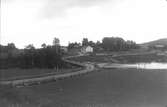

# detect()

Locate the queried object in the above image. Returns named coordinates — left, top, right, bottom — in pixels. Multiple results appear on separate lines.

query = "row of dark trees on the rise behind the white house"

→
left=68, top=37, right=139, bottom=51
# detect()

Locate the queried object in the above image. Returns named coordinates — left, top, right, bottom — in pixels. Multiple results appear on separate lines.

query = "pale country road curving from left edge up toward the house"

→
left=0, top=56, right=95, bottom=86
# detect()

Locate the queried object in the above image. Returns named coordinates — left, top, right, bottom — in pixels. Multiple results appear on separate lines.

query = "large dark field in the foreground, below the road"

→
left=0, top=69, right=167, bottom=107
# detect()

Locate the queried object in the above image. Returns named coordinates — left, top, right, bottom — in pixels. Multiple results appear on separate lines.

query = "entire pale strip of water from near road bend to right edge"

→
left=99, top=62, right=167, bottom=69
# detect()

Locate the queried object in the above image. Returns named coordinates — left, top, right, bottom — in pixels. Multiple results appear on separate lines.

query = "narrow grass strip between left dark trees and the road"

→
left=0, top=67, right=83, bottom=80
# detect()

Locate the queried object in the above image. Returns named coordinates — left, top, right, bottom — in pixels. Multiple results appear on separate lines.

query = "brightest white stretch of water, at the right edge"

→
left=123, top=62, right=167, bottom=69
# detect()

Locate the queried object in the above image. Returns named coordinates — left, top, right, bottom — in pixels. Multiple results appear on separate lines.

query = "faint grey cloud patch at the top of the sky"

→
left=41, top=0, right=111, bottom=18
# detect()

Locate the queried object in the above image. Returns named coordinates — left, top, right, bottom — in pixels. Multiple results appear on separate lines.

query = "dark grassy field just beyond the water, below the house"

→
left=70, top=52, right=167, bottom=63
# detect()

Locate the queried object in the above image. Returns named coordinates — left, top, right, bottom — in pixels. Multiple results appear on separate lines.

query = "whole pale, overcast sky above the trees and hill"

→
left=0, top=0, right=167, bottom=48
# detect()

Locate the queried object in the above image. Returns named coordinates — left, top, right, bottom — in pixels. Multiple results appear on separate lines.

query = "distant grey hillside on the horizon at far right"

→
left=141, top=38, right=167, bottom=46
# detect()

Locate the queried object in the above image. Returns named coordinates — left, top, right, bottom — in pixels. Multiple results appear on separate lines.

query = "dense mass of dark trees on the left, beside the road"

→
left=0, top=38, right=67, bottom=69
